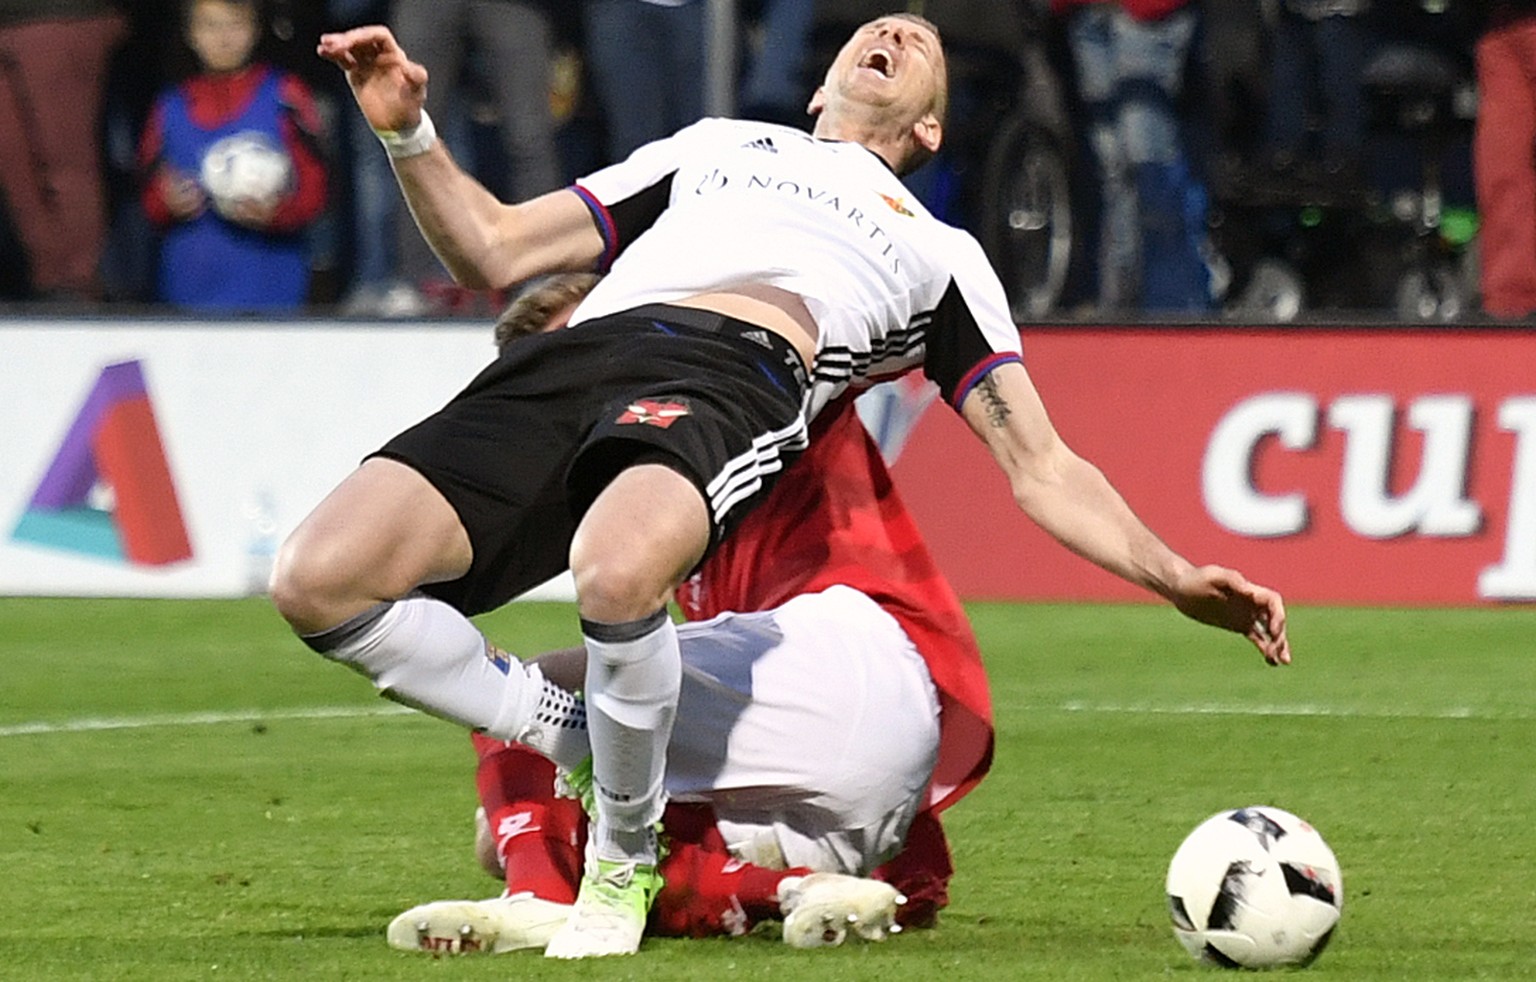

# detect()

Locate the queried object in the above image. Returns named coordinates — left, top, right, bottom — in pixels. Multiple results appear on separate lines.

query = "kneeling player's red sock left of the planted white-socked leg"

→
left=473, top=733, right=585, bottom=904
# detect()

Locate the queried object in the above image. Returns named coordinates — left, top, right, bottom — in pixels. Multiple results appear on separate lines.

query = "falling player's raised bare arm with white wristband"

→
left=316, top=25, right=604, bottom=289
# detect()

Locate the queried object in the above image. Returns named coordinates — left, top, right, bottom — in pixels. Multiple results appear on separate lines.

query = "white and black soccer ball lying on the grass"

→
left=1167, top=805, right=1344, bottom=968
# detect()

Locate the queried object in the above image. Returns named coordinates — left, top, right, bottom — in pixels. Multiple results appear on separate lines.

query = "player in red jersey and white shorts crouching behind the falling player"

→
left=387, top=274, right=992, bottom=954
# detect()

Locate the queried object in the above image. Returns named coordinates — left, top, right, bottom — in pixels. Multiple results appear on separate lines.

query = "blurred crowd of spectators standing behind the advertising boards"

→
left=0, top=0, right=1536, bottom=323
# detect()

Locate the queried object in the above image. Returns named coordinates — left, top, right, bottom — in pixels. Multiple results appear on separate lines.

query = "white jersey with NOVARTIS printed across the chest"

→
left=571, top=118, right=1021, bottom=416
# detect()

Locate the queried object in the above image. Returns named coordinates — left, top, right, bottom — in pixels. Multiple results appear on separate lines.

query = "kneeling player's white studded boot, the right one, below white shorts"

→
left=779, top=873, right=906, bottom=948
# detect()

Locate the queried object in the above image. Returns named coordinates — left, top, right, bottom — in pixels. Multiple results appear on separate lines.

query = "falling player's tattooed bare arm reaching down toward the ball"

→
left=960, top=363, right=1290, bottom=665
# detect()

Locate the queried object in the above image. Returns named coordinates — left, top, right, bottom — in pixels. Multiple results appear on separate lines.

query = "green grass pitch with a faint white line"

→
left=0, top=599, right=1536, bottom=982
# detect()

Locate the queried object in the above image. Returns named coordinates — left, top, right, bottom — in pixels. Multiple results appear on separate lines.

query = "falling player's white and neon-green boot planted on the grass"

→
left=544, top=859, right=662, bottom=959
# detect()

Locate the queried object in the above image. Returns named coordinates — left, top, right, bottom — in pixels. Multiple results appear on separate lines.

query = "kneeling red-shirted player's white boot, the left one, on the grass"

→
left=384, top=893, right=571, bottom=954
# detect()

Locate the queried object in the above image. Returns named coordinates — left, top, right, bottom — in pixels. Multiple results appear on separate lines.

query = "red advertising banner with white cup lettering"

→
left=894, top=327, right=1536, bottom=605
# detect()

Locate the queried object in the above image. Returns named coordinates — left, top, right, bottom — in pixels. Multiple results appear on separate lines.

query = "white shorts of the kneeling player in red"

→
left=667, top=587, right=938, bottom=874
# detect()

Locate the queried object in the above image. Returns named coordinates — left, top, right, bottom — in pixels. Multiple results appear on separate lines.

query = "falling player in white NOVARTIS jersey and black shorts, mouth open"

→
left=272, top=15, right=1290, bottom=957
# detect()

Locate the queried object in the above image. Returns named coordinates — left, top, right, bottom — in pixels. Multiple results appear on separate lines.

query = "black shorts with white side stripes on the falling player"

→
left=373, top=304, right=806, bottom=615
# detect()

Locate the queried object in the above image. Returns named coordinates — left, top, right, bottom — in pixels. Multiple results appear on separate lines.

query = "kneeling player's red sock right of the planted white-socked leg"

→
left=651, top=804, right=809, bottom=937
